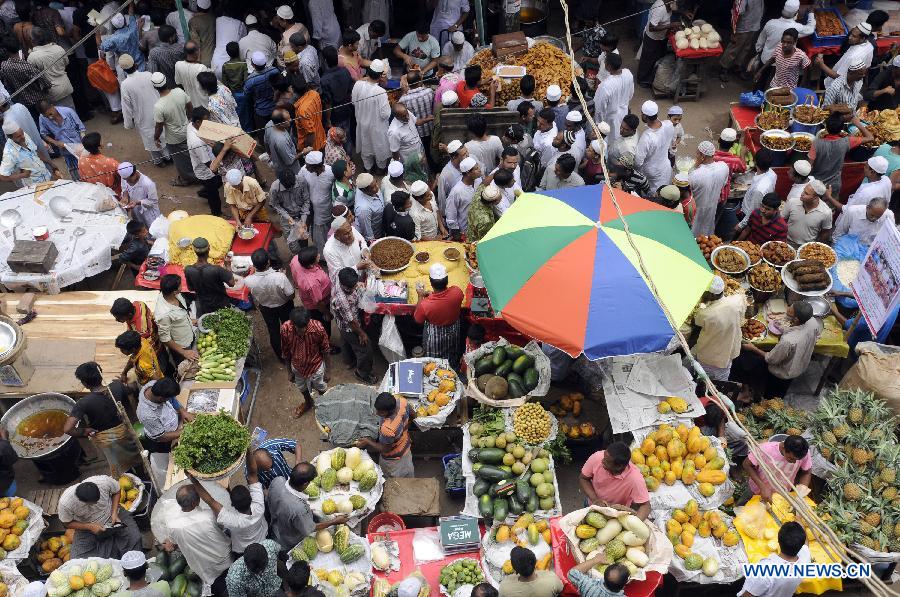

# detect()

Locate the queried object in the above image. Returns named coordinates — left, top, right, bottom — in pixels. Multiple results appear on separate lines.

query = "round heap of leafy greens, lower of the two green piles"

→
left=172, top=411, right=250, bottom=475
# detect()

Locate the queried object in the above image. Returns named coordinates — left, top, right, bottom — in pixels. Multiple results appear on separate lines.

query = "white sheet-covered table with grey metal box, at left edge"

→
left=0, top=180, right=128, bottom=292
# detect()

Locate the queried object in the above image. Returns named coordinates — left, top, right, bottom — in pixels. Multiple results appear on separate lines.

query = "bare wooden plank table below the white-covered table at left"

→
left=0, top=290, right=151, bottom=399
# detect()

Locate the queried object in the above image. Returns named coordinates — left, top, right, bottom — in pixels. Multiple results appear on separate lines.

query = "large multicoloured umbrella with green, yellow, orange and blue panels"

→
left=477, top=185, right=713, bottom=360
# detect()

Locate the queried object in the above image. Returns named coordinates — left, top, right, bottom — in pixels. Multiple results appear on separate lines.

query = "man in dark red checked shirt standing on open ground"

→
left=281, top=307, right=331, bottom=418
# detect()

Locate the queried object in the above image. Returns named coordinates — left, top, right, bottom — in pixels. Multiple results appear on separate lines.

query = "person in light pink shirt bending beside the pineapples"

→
left=743, top=435, right=812, bottom=502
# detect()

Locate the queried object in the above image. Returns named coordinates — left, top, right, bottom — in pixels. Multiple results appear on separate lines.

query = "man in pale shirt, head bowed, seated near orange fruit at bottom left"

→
left=57, top=475, right=141, bottom=560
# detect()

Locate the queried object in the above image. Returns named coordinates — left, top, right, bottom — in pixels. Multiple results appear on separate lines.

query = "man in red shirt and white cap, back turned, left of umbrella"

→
left=413, top=263, right=463, bottom=363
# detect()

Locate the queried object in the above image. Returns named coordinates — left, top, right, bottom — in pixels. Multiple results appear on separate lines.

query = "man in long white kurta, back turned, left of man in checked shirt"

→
left=350, top=60, right=391, bottom=170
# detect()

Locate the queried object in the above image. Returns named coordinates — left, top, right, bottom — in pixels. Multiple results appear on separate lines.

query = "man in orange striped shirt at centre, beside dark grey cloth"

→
left=356, top=392, right=416, bottom=477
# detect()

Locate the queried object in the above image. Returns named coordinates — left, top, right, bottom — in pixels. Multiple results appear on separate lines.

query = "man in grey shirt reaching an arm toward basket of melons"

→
left=266, top=462, right=347, bottom=549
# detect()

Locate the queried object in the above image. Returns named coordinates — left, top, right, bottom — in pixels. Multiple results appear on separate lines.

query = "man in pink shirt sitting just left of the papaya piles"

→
left=580, top=442, right=650, bottom=520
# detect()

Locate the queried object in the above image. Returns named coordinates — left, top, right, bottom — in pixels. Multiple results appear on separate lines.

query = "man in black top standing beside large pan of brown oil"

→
left=63, top=361, right=141, bottom=478
